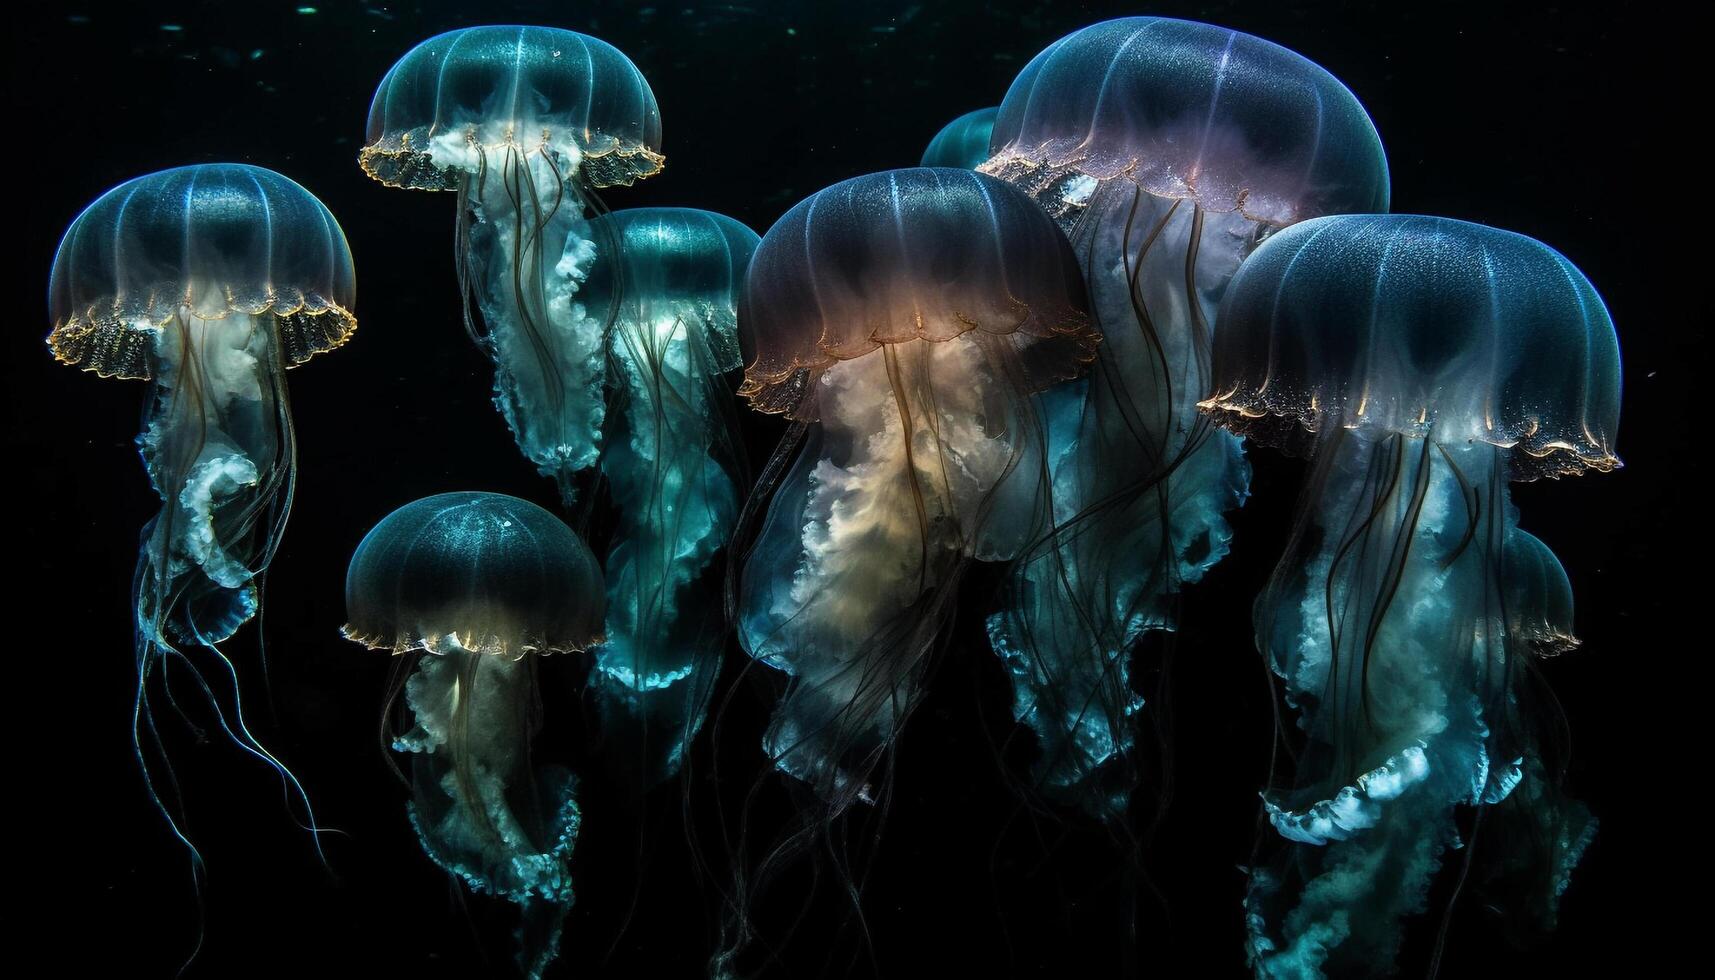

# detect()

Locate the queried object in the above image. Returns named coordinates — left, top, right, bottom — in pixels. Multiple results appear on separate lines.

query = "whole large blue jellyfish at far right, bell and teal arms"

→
left=1204, top=216, right=1621, bottom=977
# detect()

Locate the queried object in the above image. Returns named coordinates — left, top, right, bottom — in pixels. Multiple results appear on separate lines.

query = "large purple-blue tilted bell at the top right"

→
left=988, top=17, right=1387, bottom=227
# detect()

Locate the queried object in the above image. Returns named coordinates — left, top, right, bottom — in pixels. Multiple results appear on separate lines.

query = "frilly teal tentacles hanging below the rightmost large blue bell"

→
left=1247, top=422, right=1564, bottom=977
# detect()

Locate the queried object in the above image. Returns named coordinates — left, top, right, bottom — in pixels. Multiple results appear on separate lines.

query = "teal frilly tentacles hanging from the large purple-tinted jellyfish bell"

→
left=988, top=178, right=1250, bottom=819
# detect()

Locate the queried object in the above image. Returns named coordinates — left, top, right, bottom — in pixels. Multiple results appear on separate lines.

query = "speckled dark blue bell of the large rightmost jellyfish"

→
left=1202, top=215, right=1621, bottom=470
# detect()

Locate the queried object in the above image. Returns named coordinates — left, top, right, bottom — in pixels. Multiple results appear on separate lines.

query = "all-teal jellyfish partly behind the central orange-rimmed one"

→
left=585, top=208, right=758, bottom=781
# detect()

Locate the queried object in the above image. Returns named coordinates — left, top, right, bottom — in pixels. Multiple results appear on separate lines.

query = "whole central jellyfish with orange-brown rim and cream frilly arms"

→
left=737, top=168, right=1098, bottom=814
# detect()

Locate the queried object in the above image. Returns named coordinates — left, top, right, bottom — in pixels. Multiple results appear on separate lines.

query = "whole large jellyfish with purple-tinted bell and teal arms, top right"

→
left=981, top=17, right=1387, bottom=817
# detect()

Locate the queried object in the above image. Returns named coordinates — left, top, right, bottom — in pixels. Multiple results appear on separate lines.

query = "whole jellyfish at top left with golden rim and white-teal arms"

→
left=358, top=27, right=662, bottom=506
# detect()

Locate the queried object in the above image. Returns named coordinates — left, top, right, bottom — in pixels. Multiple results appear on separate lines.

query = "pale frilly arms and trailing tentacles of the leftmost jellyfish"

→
left=132, top=307, right=326, bottom=868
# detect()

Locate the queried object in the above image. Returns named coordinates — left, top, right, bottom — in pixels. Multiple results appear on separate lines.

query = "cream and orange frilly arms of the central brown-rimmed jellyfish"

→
left=741, top=335, right=1044, bottom=807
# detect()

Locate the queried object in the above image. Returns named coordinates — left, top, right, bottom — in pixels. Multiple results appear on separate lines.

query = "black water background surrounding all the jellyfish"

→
left=3, top=0, right=1687, bottom=977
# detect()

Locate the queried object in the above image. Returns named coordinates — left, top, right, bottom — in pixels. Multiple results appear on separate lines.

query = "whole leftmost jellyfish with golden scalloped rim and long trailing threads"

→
left=48, top=163, right=357, bottom=874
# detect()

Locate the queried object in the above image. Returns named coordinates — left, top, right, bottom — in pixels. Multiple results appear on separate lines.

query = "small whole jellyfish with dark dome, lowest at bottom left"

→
left=343, top=493, right=604, bottom=977
